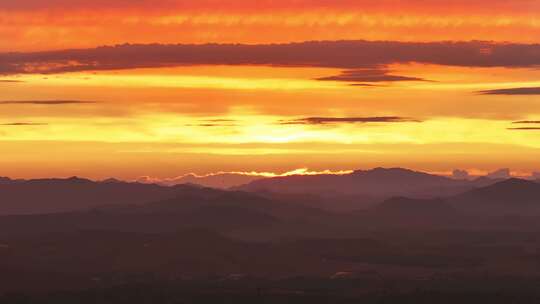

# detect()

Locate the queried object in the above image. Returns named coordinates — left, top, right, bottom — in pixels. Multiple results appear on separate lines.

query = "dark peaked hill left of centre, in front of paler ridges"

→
left=84, top=187, right=327, bottom=230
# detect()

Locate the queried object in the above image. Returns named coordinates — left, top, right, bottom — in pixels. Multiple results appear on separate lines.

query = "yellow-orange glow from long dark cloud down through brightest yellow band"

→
left=0, top=64, right=540, bottom=154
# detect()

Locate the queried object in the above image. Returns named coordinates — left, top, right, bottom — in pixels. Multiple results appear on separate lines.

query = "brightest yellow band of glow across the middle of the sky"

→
left=0, top=114, right=540, bottom=151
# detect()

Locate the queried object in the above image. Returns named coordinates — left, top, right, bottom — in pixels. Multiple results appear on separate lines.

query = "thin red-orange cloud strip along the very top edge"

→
left=0, top=0, right=539, bottom=12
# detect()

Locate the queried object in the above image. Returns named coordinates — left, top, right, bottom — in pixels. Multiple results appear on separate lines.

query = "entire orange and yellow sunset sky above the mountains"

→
left=0, top=0, right=540, bottom=179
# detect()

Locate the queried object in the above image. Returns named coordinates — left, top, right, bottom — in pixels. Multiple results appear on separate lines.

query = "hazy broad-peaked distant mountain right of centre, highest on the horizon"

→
left=236, top=168, right=495, bottom=198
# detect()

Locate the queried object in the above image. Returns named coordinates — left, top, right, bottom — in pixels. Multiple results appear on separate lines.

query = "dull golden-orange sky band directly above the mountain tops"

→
left=0, top=141, right=540, bottom=180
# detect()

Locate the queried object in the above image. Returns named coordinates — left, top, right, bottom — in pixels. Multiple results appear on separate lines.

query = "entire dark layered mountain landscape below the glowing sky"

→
left=0, top=169, right=540, bottom=293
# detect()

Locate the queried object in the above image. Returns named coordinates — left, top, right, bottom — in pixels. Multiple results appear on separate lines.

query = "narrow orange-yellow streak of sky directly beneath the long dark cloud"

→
left=4, top=63, right=540, bottom=92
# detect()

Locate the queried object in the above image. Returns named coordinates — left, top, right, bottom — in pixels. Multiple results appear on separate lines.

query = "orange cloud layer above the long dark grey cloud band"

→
left=0, top=0, right=540, bottom=51
